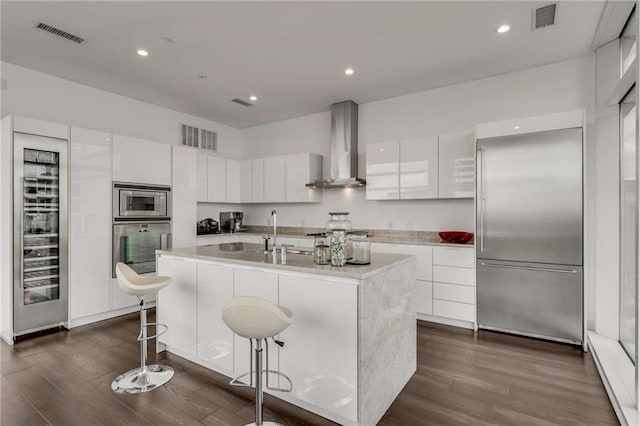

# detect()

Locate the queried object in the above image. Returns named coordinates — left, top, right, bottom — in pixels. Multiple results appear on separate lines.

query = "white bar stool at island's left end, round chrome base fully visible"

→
left=111, top=262, right=173, bottom=393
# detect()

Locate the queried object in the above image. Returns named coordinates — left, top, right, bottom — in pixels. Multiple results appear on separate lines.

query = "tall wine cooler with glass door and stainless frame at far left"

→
left=13, top=132, right=68, bottom=335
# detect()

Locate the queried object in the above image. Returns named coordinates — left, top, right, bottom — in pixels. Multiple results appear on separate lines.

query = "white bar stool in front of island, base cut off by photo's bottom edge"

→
left=222, top=296, right=293, bottom=426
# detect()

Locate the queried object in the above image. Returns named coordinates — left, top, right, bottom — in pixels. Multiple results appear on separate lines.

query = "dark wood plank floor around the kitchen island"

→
left=0, top=314, right=618, bottom=426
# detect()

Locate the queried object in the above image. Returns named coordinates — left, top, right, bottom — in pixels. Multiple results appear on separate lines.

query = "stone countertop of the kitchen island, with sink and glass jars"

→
left=156, top=243, right=415, bottom=280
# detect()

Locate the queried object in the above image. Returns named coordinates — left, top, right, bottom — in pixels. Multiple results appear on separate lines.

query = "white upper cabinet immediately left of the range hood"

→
left=285, top=152, right=322, bottom=203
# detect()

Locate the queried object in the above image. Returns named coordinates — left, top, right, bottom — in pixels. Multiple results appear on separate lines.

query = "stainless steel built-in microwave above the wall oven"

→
left=113, top=182, right=171, bottom=221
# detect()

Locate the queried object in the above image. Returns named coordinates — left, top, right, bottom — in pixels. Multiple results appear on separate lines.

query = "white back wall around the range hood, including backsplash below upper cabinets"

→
left=242, top=56, right=595, bottom=230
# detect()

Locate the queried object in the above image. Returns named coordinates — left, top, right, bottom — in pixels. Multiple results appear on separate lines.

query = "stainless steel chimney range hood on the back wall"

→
left=307, top=101, right=366, bottom=189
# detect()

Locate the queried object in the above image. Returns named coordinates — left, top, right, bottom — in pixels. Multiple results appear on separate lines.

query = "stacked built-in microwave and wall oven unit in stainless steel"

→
left=112, top=183, right=171, bottom=278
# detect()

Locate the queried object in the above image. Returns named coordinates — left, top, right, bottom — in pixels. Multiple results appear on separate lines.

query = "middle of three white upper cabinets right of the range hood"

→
left=400, top=136, right=438, bottom=200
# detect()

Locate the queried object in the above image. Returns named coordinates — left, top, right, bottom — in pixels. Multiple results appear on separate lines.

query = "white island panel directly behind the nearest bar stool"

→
left=233, top=268, right=279, bottom=384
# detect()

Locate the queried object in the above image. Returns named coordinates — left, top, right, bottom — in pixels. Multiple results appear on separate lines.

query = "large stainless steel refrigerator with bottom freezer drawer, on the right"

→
left=476, top=128, right=584, bottom=344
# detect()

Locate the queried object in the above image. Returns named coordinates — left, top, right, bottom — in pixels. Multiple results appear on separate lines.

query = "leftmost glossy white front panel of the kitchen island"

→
left=157, top=256, right=198, bottom=355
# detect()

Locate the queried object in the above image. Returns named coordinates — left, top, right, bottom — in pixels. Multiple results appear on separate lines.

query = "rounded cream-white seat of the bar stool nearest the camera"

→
left=222, top=296, right=293, bottom=339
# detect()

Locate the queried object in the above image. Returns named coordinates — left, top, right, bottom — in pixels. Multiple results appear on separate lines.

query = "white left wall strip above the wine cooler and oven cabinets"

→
left=1, top=62, right=242, bottom=159
